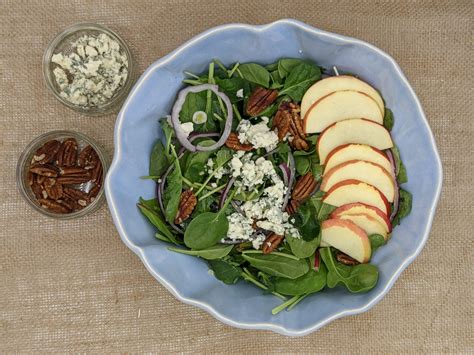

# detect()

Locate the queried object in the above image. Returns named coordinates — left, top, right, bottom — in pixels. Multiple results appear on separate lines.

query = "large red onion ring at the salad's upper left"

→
left=171, top=84, right=233, bottom=152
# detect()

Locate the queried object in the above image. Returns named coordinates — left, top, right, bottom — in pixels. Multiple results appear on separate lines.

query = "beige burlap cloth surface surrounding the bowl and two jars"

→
left=0, top=0, right=474, bottom=353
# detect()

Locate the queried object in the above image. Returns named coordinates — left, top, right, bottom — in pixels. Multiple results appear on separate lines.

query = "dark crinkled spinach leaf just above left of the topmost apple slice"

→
left=279, top=63, right=321, bottom=101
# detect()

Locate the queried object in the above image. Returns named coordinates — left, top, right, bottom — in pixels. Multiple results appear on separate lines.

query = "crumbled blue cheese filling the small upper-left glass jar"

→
left=51, top=33, right=129, bottom=107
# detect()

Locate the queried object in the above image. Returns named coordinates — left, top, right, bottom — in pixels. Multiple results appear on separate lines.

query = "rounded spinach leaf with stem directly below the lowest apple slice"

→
left=319, top=248, right=379, bottom=293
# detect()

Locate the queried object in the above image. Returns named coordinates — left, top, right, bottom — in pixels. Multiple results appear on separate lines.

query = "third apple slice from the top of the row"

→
left=318, top=118, right=393, bottom=164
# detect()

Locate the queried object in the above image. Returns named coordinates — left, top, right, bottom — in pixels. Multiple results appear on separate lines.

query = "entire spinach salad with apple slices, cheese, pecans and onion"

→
left=138, top=58, right=411, bottom=314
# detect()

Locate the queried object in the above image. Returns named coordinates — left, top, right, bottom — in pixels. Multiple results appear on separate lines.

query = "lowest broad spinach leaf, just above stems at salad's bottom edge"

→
left=273, top=265, right=327, bottom=296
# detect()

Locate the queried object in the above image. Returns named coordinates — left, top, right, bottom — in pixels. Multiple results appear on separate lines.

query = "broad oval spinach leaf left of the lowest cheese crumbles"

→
left=184, top=210, right=229, bottom=250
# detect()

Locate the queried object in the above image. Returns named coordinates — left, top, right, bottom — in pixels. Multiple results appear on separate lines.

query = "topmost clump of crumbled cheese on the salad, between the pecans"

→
left=237, top=117, right=278, bottom=152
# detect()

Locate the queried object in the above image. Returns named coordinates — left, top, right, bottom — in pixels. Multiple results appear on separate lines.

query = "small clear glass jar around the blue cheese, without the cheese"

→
left=43, top=23, right=135, bottom=116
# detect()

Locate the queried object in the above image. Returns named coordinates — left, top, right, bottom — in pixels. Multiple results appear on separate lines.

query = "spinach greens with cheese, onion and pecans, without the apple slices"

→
left=138, top=58, right=411, bottom=314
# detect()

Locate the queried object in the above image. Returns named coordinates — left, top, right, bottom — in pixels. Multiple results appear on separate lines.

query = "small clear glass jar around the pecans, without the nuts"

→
left=16, top=131, right=109, bottom=219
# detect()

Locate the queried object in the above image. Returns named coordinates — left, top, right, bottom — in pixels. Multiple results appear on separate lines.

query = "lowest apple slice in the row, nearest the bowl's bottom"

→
left=321, top=218, right=372, bottom=263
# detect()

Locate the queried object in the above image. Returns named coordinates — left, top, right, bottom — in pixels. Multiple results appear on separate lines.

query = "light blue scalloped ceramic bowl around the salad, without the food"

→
left=105, top=20, right=442, bottom=335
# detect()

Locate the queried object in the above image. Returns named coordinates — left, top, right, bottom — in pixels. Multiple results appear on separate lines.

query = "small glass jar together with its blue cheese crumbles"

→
left=43, top=23, right=134, bottom=115
